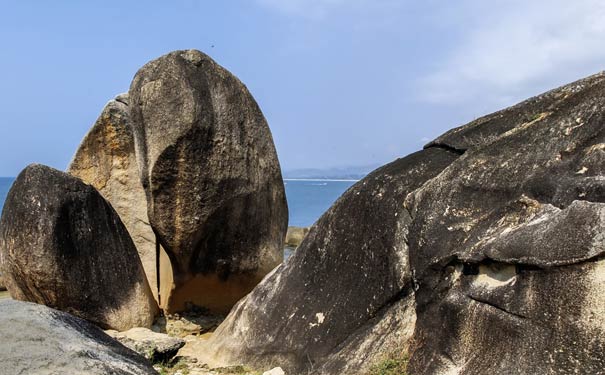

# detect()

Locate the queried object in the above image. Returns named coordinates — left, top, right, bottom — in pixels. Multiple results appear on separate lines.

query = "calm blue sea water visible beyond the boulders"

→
left=0, top=177, right=355, bottom=227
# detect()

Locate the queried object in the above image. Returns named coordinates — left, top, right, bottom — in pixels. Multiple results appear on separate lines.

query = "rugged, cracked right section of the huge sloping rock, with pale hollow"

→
left=406, top=74, right=605, bottom=375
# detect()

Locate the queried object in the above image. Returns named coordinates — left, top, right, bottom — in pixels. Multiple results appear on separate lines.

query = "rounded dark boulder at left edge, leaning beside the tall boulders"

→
left=0, top=165, right=158, bottom=330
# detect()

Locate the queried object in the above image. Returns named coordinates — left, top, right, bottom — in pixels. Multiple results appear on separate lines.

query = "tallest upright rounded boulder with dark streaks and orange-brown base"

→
left=129, top=50, right=287, bottom=312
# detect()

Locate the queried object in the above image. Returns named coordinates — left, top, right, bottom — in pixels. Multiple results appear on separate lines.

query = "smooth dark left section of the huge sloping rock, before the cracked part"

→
left=202, top=149, right=458, bottom=374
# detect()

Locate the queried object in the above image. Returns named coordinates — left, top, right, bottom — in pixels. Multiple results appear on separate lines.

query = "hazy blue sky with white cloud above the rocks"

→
left=0, top=0, right=605, bottom=176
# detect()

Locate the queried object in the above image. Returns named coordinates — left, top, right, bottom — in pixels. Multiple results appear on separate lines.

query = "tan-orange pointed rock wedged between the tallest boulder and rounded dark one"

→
left=67, top=94, right=158, bottom=300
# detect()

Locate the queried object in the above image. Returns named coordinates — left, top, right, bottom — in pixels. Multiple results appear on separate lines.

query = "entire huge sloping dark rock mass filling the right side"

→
left=202, top=74, right=605, bottom=375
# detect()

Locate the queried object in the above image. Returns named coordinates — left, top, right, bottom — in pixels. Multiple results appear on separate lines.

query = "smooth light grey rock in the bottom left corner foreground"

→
left=0, top=300, right=157, bottom=375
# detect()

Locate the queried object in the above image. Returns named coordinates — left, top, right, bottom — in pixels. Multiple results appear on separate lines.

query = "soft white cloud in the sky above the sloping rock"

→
left=419, top=0, right=605, bottom=105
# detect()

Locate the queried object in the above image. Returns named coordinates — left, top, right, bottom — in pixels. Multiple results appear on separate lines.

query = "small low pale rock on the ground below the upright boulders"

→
left=105, top=327, right=185, bottom=363
